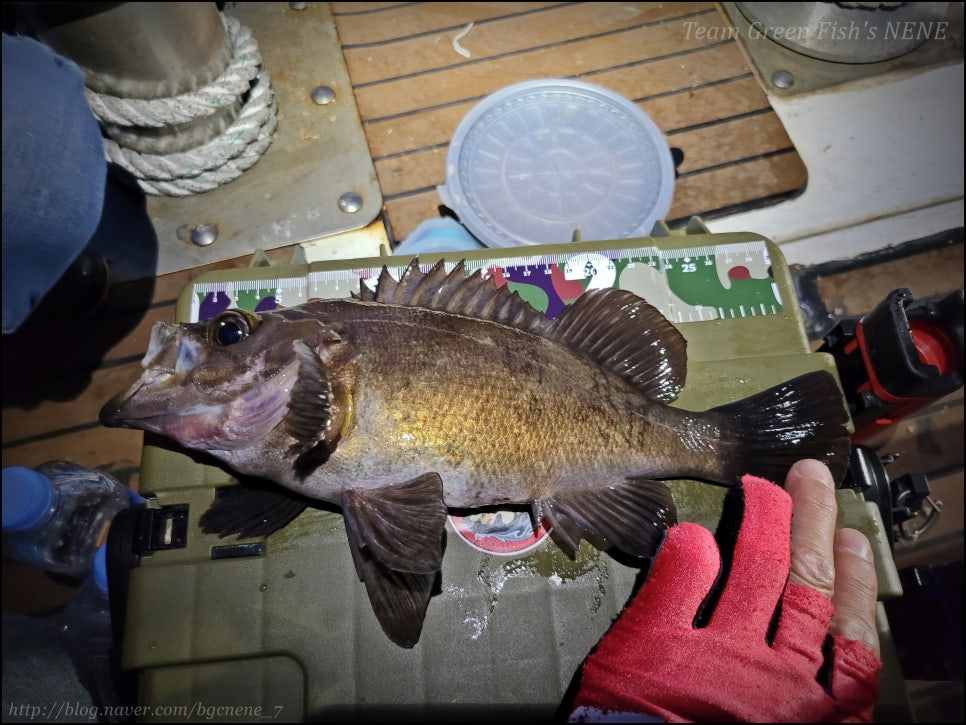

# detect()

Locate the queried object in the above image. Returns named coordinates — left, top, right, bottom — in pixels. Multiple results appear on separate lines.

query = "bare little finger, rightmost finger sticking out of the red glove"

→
left=829, top=529, right=879, bottom=655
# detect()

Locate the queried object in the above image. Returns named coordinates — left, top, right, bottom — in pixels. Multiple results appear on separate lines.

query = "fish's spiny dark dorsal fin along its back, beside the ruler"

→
left=360, top=259, right=687, bottom=403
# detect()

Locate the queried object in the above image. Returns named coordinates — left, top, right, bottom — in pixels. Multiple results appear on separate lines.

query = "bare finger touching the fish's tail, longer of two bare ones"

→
left=785, top=459, right=838, bottom=598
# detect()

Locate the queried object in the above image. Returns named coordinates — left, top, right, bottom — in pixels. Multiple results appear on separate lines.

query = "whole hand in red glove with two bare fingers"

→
left=570, top=461, right=881, bottom=722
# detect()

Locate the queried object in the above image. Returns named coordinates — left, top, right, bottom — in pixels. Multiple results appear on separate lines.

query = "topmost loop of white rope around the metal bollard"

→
left=84, top=13, right=262, bottom=128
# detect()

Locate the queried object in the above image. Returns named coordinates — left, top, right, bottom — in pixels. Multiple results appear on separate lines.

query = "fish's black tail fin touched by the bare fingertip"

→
left=711, top=371, right=851, bottom=485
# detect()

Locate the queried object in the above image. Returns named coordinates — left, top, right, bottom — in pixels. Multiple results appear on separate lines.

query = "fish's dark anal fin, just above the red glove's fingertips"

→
left=545, top=478, right=677, bottom=558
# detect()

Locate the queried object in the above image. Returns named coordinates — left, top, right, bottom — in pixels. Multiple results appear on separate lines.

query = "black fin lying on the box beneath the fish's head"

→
left=198, top=481, right=308, bottom=538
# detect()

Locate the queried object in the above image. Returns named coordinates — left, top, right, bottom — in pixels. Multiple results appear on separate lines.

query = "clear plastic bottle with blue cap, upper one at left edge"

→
left=3, top=461, right=130, bottom=578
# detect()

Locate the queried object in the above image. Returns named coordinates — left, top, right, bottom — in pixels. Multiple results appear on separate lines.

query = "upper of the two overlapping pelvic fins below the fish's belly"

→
left=342, top=473, right=446, bottom=574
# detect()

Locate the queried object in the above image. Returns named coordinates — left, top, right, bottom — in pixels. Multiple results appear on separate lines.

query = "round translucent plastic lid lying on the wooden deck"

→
left=438, top=79, right=674, bottom=247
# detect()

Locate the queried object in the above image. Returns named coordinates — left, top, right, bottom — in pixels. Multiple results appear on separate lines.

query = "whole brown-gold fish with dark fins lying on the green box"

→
left=100, top=258, right=850, bottom=648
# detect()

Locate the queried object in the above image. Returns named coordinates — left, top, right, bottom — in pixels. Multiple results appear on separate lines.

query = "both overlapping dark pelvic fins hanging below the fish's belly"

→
left=342, top=473, right=446, bottom=648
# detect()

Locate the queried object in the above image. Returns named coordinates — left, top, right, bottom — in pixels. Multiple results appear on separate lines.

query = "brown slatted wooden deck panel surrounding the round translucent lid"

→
left=331, top=2, right=806, bottom=240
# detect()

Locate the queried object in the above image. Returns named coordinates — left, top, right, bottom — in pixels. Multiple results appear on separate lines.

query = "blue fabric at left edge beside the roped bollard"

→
left=3, top=34, right=107, bottom=334
